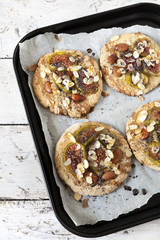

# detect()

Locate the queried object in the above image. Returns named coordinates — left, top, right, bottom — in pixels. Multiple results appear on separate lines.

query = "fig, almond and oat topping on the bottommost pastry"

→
left=64, top=125, right=127, bottom=186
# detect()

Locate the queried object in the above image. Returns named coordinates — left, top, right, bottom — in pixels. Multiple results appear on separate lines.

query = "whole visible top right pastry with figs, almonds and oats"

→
left=100, top=32, right=160, bottom=96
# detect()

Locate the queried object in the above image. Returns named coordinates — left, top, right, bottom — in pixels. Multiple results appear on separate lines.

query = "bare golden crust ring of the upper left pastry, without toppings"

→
left=33, top=50, right=102, bottom=118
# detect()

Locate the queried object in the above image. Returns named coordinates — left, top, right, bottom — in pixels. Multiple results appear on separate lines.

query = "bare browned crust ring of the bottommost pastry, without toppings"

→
left=55, top=122, right=131, bottom=196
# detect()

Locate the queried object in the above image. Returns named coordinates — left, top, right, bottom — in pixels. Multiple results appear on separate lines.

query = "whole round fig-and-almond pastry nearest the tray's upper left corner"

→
left=33, top=50, right=102, bottom=118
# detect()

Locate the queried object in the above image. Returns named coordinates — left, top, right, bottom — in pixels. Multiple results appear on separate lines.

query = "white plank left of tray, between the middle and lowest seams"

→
left=0, top=126, right=48, bottom=199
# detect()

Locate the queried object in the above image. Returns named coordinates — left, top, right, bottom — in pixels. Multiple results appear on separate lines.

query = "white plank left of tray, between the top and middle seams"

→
left=0, top=59, right=28, bottom=124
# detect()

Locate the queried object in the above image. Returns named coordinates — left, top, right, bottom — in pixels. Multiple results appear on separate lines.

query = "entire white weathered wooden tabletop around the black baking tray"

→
left=0, top=0, right=160, bottom=240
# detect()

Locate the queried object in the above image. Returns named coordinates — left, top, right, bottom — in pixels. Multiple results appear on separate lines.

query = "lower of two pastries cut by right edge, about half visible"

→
left=126, top=101, right=160, bottom=171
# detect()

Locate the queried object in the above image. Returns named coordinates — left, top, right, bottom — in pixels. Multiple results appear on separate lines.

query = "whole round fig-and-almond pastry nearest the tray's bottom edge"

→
left=55, top=121, right=132, bottom=196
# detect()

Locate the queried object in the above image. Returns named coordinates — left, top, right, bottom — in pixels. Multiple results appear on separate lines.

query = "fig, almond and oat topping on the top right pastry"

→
left=108, top=38, right=160, bottom=93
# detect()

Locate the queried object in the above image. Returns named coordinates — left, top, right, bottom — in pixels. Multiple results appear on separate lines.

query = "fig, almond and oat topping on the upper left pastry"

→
left=40, top=52, right=99, bottom=106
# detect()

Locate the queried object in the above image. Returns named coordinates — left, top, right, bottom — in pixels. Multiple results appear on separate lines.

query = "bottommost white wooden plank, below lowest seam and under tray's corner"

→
left=0, top=201, right=160, bottom=240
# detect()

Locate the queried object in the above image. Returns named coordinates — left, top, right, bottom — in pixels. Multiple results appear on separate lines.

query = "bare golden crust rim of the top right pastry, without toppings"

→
left=100, top=32, right=160, bottom=96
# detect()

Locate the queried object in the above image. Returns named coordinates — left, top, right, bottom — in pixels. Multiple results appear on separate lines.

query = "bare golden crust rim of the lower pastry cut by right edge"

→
left=126, top=101, right=160, bottom=171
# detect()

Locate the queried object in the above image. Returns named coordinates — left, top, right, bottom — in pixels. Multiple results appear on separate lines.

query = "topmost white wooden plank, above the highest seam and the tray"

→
left=0, top=0, right=146, bottom=58
